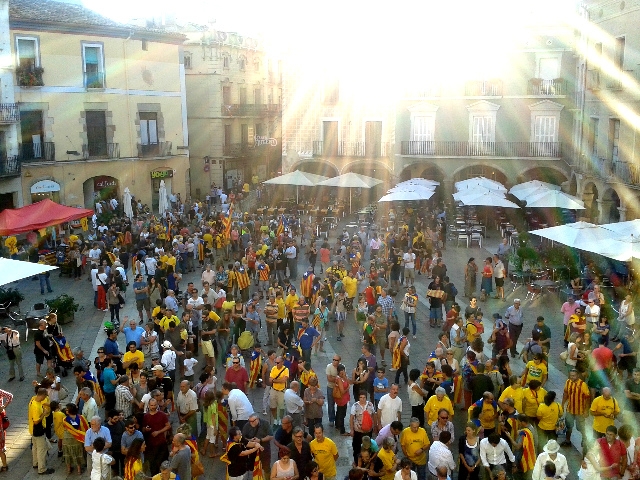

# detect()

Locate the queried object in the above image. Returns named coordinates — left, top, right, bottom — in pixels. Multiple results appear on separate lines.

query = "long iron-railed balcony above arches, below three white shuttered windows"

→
left=400, top=141, right=562, bottom=158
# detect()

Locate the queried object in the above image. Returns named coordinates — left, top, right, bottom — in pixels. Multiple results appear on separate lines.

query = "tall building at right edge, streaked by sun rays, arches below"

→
left=570, top=0, right=640, bottom=223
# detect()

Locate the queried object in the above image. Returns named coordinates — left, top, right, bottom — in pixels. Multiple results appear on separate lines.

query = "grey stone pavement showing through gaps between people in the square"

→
left=0, top=216, right=592, bottom=478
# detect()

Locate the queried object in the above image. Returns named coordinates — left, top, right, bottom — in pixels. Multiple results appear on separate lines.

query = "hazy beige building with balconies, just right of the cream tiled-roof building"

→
left=181, top=25, right=282, bottom=194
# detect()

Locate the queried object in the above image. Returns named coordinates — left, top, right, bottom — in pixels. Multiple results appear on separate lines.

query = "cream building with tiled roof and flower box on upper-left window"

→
left=8, top=0, right=189, bottom=211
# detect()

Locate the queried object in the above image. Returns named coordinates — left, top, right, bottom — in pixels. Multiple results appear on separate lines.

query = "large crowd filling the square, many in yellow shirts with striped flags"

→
left=11, top=188, right=640, bottom=480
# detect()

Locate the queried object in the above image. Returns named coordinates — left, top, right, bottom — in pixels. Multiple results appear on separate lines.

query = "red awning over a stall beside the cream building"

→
left=0, top=198, right=93, bottom=237
